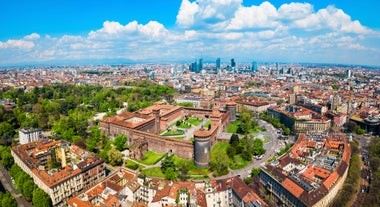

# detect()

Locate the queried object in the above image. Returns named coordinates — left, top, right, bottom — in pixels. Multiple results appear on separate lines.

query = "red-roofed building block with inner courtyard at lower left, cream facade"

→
left=11, top=140, right=105, bottom=206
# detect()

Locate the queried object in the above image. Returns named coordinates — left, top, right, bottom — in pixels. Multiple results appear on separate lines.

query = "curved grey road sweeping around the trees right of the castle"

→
left=210, top=119, right=278, bottom=179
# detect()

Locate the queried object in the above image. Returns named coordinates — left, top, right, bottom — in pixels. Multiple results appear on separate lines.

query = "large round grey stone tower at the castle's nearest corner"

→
left=194, top=128, right=211, bottom=168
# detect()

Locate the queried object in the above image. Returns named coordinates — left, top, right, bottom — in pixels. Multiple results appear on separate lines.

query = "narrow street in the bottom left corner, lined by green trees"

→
left=0, top=164, right=33, bottom=207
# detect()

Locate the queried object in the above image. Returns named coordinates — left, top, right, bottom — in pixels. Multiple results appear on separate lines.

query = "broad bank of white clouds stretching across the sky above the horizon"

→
left=0, top=0, right=380, bottom=65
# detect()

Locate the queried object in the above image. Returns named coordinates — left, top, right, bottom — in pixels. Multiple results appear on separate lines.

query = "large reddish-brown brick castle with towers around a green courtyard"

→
left=99, top=103, right=236, bottom=167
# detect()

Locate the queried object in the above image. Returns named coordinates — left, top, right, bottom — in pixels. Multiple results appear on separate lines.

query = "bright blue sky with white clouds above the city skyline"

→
left=0, top=0, right=380, bottom=66
